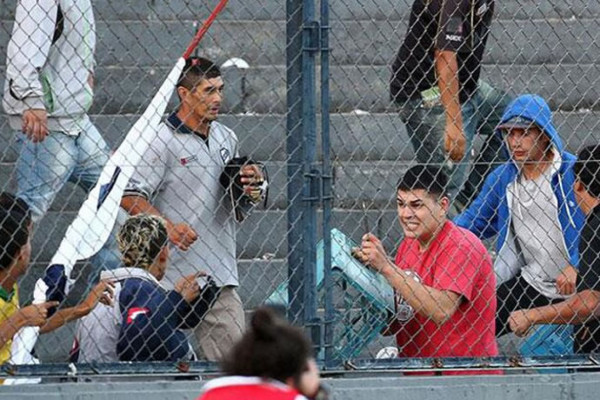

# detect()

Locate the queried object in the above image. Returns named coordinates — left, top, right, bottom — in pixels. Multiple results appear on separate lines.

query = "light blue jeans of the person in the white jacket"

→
left=16, top=120, right=120, bottom=286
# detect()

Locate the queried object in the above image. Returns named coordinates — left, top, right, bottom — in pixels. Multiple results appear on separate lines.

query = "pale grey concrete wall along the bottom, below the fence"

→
left=0, top=373, right=600, bottom=400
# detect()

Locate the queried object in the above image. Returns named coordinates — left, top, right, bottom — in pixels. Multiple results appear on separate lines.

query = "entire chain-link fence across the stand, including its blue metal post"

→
left=0, top=0, right=600, bottom=378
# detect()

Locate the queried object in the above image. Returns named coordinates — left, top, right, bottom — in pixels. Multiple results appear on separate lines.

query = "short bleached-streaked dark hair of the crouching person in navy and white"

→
left=117, top=214, right=169, bottom=269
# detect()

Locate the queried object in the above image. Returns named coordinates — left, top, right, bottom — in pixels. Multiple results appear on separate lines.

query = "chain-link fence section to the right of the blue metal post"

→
left=322, top=1, right=597, bottom=365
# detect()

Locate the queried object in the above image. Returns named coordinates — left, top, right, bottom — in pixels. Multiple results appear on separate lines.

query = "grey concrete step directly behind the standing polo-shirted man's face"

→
left=0, top=63, right=600, bottom=114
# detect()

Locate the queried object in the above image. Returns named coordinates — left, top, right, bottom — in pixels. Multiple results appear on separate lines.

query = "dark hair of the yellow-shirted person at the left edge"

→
left=0, top=192, right=31, bottom=270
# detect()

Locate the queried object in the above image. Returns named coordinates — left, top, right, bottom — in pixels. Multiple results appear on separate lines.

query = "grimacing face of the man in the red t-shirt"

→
left=397, top=189, right=448, bottom=243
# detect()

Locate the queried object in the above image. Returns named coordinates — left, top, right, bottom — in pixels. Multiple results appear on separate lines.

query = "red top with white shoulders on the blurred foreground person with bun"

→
left=198, top=376, right=306, bottom=400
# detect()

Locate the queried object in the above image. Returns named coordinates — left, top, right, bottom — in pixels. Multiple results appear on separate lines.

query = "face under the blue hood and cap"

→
left=505, top=126, right=550, bottom=163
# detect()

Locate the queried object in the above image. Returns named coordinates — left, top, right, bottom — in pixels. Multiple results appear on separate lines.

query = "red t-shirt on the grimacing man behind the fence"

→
left=395, top=221, right=498, bottom=357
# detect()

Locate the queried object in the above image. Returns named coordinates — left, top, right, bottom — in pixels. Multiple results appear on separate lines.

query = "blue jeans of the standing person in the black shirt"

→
left=399, top=81, right=511, bottom=205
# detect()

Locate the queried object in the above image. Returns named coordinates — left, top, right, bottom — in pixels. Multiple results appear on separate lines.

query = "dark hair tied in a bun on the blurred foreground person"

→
left=223, top=307, right=312, bottom=382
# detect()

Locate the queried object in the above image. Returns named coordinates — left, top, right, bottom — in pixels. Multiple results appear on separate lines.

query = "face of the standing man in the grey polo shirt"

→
left=180, top=76, right=225, bottom=121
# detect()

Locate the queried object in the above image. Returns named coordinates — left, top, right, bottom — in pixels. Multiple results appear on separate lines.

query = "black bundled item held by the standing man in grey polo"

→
left=219, top=157, right=269, bottom=222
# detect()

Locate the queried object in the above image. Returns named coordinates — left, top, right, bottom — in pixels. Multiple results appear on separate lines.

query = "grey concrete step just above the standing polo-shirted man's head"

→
left=0, top=17, right=600, bottom=69
